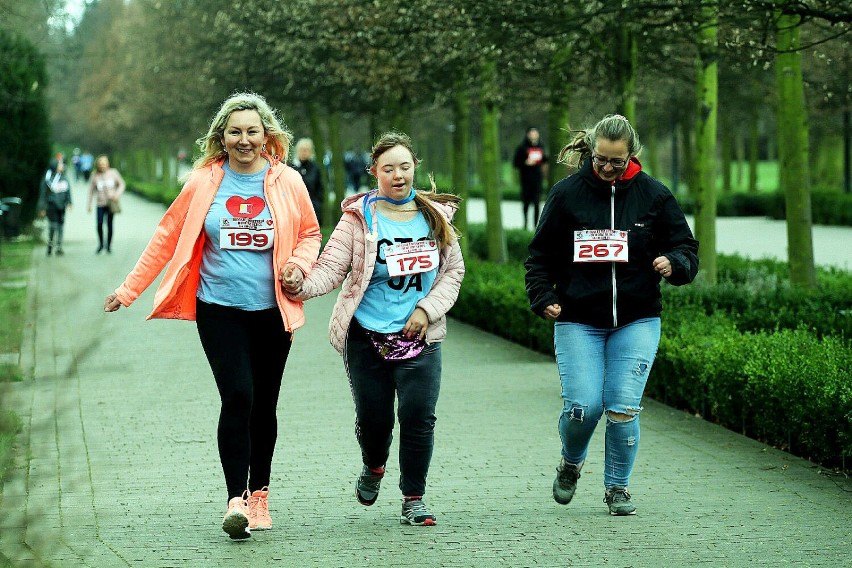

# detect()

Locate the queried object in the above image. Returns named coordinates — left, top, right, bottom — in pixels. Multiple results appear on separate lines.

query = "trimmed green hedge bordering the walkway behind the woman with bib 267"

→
left=450, top=225, right=852, bottom=466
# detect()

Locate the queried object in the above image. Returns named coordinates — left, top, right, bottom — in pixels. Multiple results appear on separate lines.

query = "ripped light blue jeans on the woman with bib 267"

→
left=553, top=318, right=660, bottom=489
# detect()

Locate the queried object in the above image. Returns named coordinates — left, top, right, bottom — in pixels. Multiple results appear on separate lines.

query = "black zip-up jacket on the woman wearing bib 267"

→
left=524, top=158, right=698, bottom=328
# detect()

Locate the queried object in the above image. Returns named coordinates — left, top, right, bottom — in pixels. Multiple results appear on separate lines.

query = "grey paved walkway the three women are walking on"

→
left=0, top=181, right=852, bottom=568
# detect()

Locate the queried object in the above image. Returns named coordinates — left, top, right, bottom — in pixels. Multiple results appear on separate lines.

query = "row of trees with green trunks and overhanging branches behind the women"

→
left=4, top=0, right=852, bottom=286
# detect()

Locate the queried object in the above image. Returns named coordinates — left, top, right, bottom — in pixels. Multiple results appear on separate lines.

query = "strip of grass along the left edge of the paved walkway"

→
left=0, top=242, right=33, bottom=481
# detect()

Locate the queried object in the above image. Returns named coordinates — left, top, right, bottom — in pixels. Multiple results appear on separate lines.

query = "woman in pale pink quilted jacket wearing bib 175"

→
left=281, top=132, right=464, bottom=525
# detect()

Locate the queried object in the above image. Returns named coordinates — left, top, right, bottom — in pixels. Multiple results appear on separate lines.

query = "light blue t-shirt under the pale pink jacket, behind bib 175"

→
left=355, top=212, right=438, bottom=333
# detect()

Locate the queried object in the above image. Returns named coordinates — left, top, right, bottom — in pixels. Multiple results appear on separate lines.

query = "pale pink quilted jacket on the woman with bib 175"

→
left=294, top=193, right=464, bottom=355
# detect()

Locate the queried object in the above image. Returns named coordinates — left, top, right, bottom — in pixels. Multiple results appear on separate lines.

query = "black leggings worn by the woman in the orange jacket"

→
left=196, top=300, right=292, bottom=499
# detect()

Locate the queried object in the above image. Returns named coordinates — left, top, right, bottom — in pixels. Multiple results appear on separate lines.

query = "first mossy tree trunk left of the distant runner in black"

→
left=480, top=61, right=508, bottom=263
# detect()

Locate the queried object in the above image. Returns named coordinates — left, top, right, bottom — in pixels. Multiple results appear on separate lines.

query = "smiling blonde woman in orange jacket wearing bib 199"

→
left=104, top=93, right=321, bottom=539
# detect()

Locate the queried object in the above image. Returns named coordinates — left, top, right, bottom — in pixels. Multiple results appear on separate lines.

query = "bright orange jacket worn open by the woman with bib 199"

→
left=115, top=154, right=322, bottom=333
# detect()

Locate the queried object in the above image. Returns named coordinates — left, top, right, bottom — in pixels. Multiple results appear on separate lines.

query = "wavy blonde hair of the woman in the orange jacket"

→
left=192, top=92, right=293, bottom=170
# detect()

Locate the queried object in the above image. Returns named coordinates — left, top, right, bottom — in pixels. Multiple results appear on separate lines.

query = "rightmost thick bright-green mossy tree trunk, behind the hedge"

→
left=775, top=13, right=816, bottom=289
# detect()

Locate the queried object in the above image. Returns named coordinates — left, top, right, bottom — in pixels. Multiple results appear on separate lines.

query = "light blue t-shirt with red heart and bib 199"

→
left=198, top=162, right=277, bottom=311
